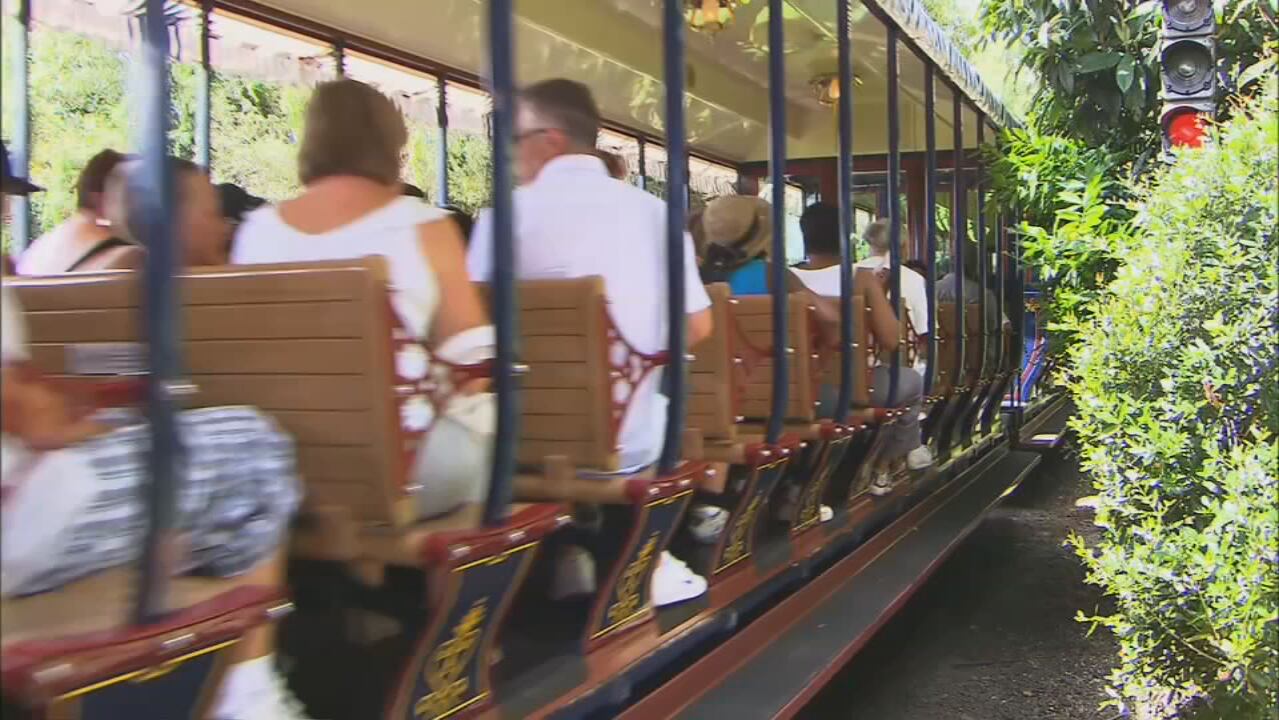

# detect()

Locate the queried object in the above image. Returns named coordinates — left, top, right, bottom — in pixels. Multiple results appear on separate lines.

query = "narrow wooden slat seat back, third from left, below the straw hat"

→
left=687, top=283, right=741, bottom=442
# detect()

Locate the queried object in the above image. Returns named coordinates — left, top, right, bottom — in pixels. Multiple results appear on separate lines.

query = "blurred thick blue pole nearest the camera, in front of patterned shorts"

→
left=129, top=0, right=182, bottom=624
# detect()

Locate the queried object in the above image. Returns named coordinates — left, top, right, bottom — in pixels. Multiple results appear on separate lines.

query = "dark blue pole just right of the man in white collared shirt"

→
left=657, top=0, right=692, bottom=476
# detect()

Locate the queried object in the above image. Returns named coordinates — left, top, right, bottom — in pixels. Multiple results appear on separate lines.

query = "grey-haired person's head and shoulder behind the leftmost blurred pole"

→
left=92, top=157, right=235, bottom=270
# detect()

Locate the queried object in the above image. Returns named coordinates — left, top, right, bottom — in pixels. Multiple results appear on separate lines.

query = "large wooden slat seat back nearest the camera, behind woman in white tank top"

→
left=10, top=258, right=413, bottom=527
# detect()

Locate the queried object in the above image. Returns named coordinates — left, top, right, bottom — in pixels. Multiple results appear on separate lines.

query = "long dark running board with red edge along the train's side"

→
left=622, top=450, right=1040, bottom=720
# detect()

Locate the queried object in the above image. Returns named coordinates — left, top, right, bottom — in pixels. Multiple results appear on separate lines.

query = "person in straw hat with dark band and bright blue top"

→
left=701, top=194, right=773, bottom=295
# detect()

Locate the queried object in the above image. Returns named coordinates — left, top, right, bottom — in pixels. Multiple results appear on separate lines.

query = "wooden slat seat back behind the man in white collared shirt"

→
left=483, top=276, right=620, bottom=471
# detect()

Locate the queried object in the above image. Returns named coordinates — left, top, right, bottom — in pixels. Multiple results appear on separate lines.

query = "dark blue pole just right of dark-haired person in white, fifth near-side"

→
left=834, top=0, right=865, bottom=422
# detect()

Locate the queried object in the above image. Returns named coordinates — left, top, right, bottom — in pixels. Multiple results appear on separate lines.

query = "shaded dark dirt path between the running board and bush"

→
left=801, top=457, right=1114, bottom=720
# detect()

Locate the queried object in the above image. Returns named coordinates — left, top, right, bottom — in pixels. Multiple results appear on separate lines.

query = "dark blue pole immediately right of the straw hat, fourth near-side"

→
left=765, top=0, right=790, bottom=445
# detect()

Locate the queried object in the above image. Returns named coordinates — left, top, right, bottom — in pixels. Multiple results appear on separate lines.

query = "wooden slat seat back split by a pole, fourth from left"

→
left=733, top=295, right=820, bottom=422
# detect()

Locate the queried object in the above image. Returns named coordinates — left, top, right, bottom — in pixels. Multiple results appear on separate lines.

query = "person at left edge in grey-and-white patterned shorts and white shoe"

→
left=0, top=147, right=312, bottom=720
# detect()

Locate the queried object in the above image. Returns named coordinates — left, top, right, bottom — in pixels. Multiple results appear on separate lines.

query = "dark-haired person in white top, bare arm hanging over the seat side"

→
left=790, top=202, right=932, bottom=494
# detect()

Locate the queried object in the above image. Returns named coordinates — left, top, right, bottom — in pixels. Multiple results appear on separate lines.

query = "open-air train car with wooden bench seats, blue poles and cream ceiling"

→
left=3, top=0, right=1060, bottom=720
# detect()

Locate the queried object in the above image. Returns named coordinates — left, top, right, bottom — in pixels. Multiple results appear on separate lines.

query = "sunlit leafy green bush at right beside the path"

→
left=1065, top=83, right=1279, bottom=720
